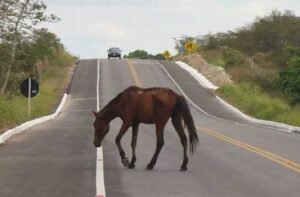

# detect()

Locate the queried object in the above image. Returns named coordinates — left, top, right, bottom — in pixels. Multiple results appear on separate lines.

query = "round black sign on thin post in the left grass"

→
left=20, top=78, right=39, bottom=119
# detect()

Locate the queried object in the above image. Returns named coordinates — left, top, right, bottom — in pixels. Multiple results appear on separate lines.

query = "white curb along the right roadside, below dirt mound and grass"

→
left=175, top=61, right=300, bottom=133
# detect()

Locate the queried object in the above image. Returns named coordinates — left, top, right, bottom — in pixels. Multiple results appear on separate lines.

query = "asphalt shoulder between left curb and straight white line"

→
left=0, top=60, right=97, bottom=197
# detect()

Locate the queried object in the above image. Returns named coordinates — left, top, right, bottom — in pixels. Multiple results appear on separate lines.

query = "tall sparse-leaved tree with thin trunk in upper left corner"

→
left=0, top=0, right=59, bottom=93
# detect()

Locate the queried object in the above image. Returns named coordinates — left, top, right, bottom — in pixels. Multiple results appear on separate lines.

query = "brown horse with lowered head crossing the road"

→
left=93, top=86, right=198, bottom=171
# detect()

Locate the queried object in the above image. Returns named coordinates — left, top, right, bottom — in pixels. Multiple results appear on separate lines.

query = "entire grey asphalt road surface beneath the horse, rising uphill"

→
left=0, top=59, right=300, bottom=197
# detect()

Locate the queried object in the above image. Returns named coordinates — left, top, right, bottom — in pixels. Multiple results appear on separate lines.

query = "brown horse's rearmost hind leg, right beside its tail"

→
left=172, top=114, right=188, bottom=171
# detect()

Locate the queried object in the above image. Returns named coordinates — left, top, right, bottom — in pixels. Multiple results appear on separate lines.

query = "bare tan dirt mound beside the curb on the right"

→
left=175, top=54, right=233, bottom=87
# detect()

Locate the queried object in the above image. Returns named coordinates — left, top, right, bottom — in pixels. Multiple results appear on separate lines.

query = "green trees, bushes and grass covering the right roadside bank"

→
left=176, top=10, right=300, bottom=126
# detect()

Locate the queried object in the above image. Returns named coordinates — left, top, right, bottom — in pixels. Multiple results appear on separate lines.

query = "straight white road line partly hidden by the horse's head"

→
left=96, top=59, right=105, bottom=197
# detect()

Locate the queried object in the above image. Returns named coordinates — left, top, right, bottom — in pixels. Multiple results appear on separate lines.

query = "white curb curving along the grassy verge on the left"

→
left=0, top=93, right=68, bottom=144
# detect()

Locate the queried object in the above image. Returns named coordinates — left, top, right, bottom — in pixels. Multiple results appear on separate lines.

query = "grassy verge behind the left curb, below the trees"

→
left=0, top=57, right=74, bottom=133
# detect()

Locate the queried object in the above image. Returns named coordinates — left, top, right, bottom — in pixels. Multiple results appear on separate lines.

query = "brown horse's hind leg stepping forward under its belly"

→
left=146, top=122, right=166, bottom=170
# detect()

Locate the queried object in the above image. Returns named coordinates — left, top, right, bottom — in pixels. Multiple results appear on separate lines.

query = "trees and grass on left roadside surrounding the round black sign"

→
left=0, top=0, right=75, bottom=133
